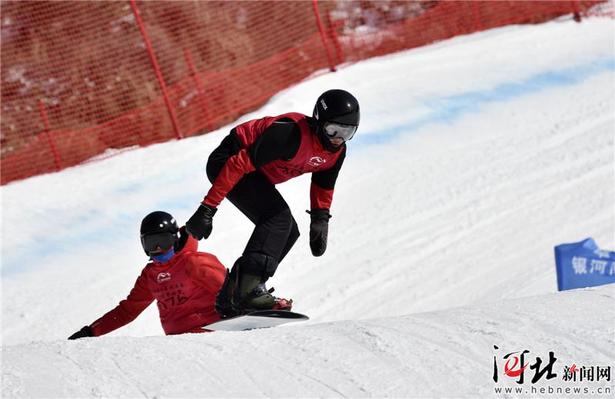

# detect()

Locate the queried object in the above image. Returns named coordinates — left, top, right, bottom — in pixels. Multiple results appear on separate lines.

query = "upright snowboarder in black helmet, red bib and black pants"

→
left=186, top=89, right=360, bottom=317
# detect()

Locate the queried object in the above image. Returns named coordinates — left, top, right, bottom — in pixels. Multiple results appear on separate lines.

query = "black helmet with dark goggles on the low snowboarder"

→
left=141, top=211, right=179, bottom=256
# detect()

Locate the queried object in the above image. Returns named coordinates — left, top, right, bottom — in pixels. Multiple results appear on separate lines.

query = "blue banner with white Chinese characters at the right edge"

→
left=555, top=238, right=615, bottom=291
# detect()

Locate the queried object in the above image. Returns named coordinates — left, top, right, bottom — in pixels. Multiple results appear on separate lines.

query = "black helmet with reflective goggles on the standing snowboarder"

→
left=312, top=89, right=361, bottom=149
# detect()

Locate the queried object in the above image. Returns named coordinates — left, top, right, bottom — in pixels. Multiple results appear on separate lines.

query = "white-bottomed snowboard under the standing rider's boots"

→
left=203, top=310, right=309, bottom=331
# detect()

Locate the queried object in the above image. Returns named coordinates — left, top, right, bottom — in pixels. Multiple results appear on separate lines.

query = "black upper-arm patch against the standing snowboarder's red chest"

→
left=248, top=119, right=301, bottom=169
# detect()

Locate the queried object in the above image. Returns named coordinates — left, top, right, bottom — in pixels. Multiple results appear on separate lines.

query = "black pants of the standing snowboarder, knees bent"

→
left=207, top=132, right=299, bottom=277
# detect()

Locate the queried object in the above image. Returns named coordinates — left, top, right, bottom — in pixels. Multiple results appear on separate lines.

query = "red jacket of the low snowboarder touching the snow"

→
left=91, top=237, right=226, bottom=336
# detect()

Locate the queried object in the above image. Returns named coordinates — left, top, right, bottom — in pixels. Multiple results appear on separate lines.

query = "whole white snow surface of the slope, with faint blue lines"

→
left=1, top=18, right=615, bottom=398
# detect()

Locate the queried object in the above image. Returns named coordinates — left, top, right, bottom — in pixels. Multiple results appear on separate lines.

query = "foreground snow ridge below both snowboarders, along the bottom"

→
left=2, top=286, right=615, bottom=398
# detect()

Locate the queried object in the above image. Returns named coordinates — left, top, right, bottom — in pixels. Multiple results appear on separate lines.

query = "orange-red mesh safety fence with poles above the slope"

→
left=0, top=0, right=612, bottom=184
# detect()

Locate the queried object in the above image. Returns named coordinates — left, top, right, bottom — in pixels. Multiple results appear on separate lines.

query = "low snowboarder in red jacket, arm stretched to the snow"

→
left=68, top=211, right=226, bottom=339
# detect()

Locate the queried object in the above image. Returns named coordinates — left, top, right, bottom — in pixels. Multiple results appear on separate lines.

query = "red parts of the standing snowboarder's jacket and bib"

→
left=203, top=112, right=341, bottom=209
